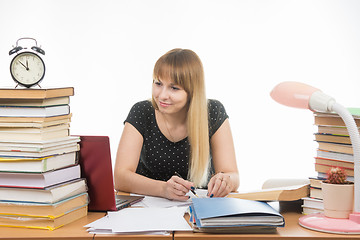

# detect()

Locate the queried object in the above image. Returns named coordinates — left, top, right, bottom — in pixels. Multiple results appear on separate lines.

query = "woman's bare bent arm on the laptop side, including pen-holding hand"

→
left=114, top=122, right=193, bottom=200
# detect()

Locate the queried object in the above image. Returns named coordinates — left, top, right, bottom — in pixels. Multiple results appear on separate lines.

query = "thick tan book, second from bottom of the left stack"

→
left=0, top=193, right=89, bottom=218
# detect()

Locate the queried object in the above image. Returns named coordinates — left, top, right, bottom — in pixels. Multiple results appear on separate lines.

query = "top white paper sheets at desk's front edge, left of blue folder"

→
left=84, top=207, right=192, bottom=235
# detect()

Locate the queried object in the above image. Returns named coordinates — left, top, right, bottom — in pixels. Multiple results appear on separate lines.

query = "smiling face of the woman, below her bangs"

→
left=152, top=78, right=188, bottom=114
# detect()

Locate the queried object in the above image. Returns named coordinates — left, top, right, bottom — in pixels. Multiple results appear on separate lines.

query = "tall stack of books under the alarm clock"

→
left=0, top=87, right=88, bottom=230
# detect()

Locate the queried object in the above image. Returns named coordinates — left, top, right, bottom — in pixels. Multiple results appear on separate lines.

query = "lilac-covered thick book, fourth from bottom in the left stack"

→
left=0, top=165, right=80, bottom=188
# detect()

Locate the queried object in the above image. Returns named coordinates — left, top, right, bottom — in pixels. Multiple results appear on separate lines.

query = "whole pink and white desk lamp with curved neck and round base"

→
left=270, top=82, right=360, bottom=234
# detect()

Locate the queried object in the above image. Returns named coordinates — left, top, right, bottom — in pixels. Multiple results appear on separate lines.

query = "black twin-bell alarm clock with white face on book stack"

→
left=9, top=38, right=45, bottom=88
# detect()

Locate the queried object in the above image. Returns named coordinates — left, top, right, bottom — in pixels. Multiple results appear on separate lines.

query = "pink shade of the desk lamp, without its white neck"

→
left=270, top=82, right=320, bottom=109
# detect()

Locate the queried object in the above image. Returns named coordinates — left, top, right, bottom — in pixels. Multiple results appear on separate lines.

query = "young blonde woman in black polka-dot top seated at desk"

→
left=114, top=49, right=239, bottom=201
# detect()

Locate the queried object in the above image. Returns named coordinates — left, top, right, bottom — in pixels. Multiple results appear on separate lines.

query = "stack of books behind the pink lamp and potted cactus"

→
left=303, top=108, right=360, bottom=214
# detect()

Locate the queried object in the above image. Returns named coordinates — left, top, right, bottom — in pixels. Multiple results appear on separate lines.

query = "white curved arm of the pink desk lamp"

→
left=332, top=102, right=360, bottom=213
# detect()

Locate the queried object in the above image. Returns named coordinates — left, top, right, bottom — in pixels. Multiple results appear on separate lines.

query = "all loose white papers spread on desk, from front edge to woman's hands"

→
left=84, top=189, right=207, bottom=235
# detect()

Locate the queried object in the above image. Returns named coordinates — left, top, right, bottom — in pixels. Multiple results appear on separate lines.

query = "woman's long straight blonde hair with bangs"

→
left=152, top=48, right=210, bottom=187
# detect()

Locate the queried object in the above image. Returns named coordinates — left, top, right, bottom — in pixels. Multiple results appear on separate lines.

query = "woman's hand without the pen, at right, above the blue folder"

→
left=208, top=172, right=232, bottom=197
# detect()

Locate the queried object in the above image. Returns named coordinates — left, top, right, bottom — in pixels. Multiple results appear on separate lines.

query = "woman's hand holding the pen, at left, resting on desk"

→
left=163, top=176, right=194, bottom=201
